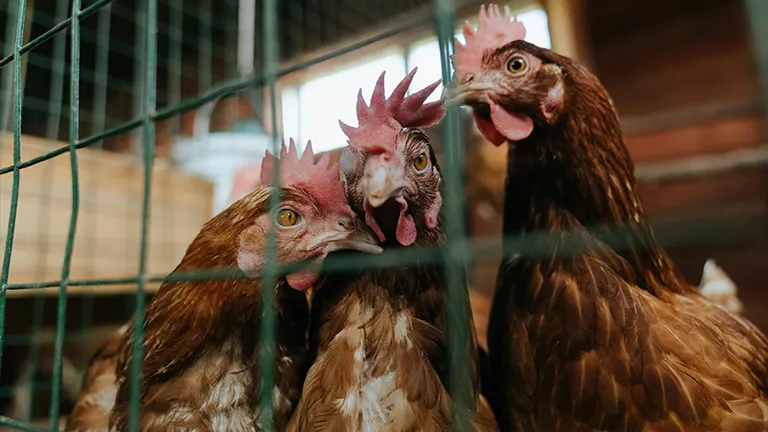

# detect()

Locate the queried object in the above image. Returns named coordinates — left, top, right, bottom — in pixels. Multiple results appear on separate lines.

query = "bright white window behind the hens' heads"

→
left=281, top=9, right=551, bottom=152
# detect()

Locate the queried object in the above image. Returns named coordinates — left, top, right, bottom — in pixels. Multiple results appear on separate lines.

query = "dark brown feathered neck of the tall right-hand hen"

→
left=504, top=103, right=692, bottom=295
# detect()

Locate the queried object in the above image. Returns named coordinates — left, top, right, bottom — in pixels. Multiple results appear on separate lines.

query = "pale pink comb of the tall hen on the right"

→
left=451, top=4, right=525, bottom=75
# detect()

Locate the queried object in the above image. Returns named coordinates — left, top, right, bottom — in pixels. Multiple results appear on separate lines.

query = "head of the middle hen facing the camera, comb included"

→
left=340, top=68, right=445, bottom=246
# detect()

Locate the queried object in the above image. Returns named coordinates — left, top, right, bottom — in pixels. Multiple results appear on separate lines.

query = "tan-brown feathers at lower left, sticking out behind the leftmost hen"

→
left=64, top=325, right=128, bottom=432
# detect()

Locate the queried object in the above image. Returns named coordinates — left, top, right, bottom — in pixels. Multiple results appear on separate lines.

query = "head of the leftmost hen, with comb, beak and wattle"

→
left=237, top=139, right=382, bottom=291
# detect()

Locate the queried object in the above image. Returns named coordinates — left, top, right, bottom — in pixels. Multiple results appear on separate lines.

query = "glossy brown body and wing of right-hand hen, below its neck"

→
left=489, top=211, right=768, bottom=431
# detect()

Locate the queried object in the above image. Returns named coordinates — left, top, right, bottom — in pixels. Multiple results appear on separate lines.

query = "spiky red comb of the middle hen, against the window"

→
left=339, top=68, right=445, bottom=151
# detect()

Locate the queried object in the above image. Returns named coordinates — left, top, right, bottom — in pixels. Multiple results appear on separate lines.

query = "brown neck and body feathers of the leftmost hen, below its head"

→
left=111, top=187, right=309, bottom=431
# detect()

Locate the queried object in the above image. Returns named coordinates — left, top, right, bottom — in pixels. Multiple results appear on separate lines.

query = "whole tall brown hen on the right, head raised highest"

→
left=445, top=6, right=768, bottom=431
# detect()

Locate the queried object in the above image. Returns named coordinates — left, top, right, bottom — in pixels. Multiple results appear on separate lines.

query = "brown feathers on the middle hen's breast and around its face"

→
left=288, top=129, right=497, bottom=432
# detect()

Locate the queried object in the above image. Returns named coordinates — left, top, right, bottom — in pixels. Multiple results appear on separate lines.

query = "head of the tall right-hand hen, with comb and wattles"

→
left=443, top=5, right=566, bottom=145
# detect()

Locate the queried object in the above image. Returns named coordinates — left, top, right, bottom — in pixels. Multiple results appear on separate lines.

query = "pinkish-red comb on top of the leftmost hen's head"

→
left=261, top=138, right=342, bottom=191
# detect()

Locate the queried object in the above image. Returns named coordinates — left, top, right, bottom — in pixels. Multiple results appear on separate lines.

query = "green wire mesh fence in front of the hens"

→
left=0, top=0, right=476, bottom=431
